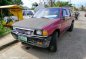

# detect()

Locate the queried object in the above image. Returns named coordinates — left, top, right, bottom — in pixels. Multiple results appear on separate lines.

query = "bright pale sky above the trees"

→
left=22, top=0, right=86, bottom=8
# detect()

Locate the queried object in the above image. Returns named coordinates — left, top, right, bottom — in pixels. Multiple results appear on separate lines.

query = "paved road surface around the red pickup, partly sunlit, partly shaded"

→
left=0, top=12, right=86, bottom=59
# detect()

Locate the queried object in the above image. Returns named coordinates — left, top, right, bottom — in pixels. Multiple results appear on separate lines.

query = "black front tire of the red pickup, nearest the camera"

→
left=48, top=32, right=58, bottom=52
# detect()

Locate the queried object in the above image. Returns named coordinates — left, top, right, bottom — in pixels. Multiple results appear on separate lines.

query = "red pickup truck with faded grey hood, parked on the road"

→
left=12, top=7, right=74, bottom=52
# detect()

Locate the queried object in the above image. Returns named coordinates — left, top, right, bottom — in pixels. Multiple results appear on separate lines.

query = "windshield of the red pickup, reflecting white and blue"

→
left=33, top=8, right=59, bottom=19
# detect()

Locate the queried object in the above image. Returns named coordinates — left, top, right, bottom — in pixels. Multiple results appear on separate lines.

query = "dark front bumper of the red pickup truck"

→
left=11, top=32, right=51, bottom=48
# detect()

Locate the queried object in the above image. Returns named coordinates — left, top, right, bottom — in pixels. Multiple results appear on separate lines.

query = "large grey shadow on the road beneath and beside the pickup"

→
left=22, top=28, right=86, bottom=59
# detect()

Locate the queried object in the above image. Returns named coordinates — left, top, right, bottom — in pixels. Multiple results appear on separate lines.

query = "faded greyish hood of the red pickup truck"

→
left=13, top=18, right=55, bottom=29
